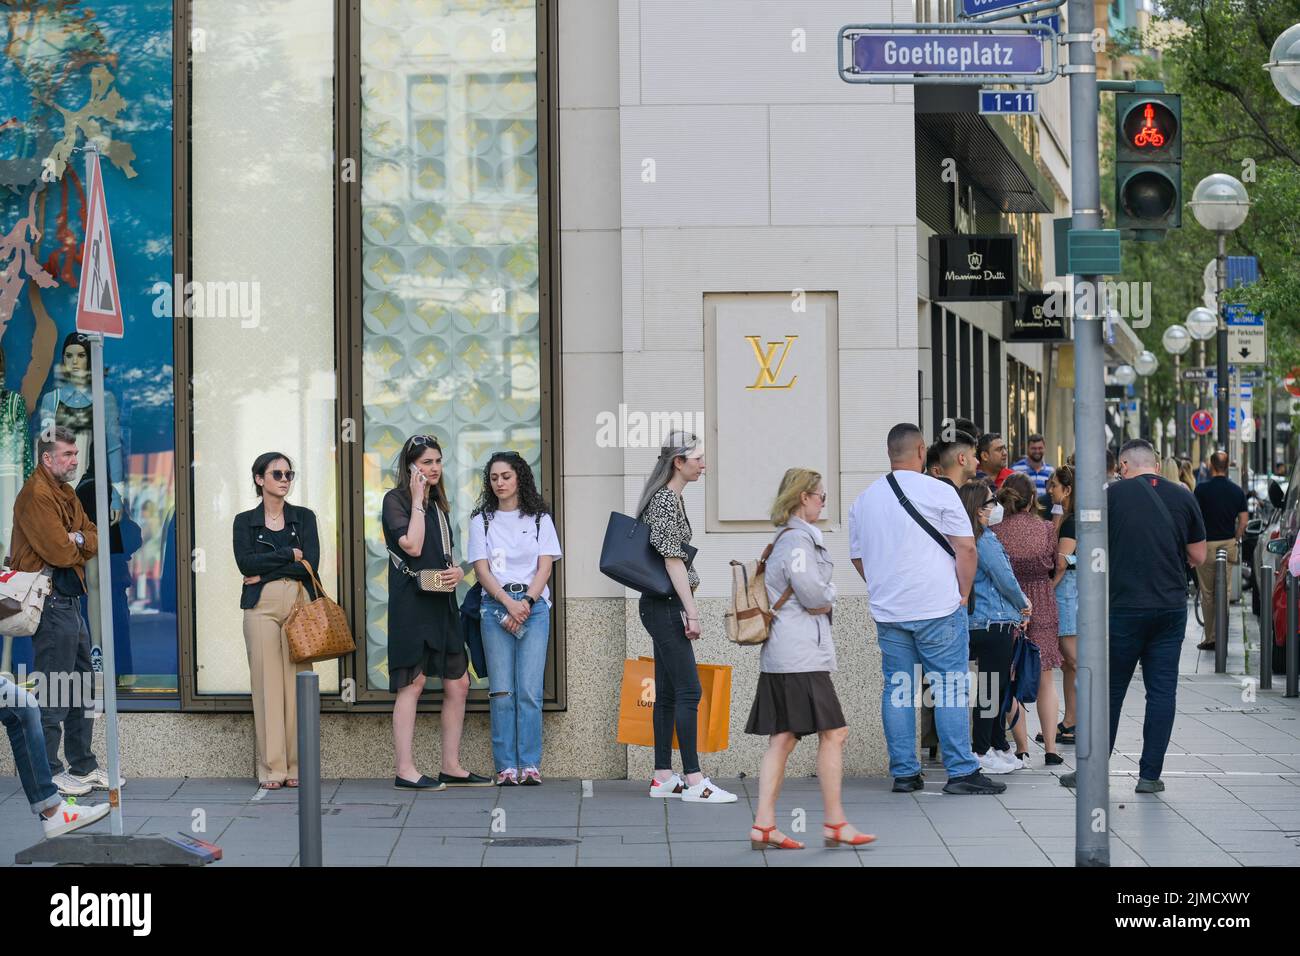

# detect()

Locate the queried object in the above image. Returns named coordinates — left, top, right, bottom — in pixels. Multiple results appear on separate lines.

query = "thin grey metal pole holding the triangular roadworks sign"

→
left=86, top=335, right=122, bottom=836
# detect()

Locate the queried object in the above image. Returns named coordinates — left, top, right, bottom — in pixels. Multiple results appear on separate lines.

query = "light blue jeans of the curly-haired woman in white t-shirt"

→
left=480, top=594, right=551, bottom=773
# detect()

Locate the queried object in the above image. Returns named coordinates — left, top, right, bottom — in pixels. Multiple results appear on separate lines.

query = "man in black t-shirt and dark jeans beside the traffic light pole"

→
left=1061, top=438, right=1205, bottom=793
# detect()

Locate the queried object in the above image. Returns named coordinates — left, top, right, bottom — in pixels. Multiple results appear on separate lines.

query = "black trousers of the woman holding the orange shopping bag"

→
left=640, top=594, right=701, bottom=774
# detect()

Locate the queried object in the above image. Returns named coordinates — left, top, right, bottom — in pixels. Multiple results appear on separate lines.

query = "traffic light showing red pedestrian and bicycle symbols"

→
left=1115, top=92, right=1183, bottom=242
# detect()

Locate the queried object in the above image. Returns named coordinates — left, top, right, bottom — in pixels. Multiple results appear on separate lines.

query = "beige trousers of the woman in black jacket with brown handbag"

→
left=244, top=580, right=312, bottom=783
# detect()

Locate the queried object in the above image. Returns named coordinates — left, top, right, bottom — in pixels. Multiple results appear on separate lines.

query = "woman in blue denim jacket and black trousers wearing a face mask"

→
left=957, top=480, right=1031, bottom=774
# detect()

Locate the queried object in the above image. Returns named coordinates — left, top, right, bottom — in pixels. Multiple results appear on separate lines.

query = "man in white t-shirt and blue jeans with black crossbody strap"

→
left=849, top=423, right=1006, bottom=793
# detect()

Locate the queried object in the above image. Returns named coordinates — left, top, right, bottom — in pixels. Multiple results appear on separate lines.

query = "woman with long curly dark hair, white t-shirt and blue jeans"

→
left=468, top=451, right=560, bottom=787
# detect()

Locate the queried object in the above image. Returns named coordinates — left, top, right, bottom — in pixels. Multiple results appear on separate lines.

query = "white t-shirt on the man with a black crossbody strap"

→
left=849, top=471, right=975, bottom=622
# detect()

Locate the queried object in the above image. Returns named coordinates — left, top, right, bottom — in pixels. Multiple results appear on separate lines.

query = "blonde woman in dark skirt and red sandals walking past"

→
left=745, top=468, right=876, bottom=849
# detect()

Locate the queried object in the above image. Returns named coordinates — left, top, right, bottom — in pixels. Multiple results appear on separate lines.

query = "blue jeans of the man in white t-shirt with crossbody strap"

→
left=876, top=607, right=979, bottom=778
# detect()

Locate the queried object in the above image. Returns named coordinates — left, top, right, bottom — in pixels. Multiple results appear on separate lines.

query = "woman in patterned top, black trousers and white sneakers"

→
left=637, top=432, right=736, bottom=804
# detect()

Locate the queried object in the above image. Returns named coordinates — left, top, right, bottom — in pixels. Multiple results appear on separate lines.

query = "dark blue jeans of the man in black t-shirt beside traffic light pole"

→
left=1110, top=607, right=1187, bottom=780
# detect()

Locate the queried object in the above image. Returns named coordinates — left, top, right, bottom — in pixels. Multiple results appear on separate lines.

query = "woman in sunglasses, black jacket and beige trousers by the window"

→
left=234, top=451, right=321, bottom=790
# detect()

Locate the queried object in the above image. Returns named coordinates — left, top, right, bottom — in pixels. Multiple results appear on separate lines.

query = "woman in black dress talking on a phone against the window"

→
left=384, top=434, right=491, bottom=791
